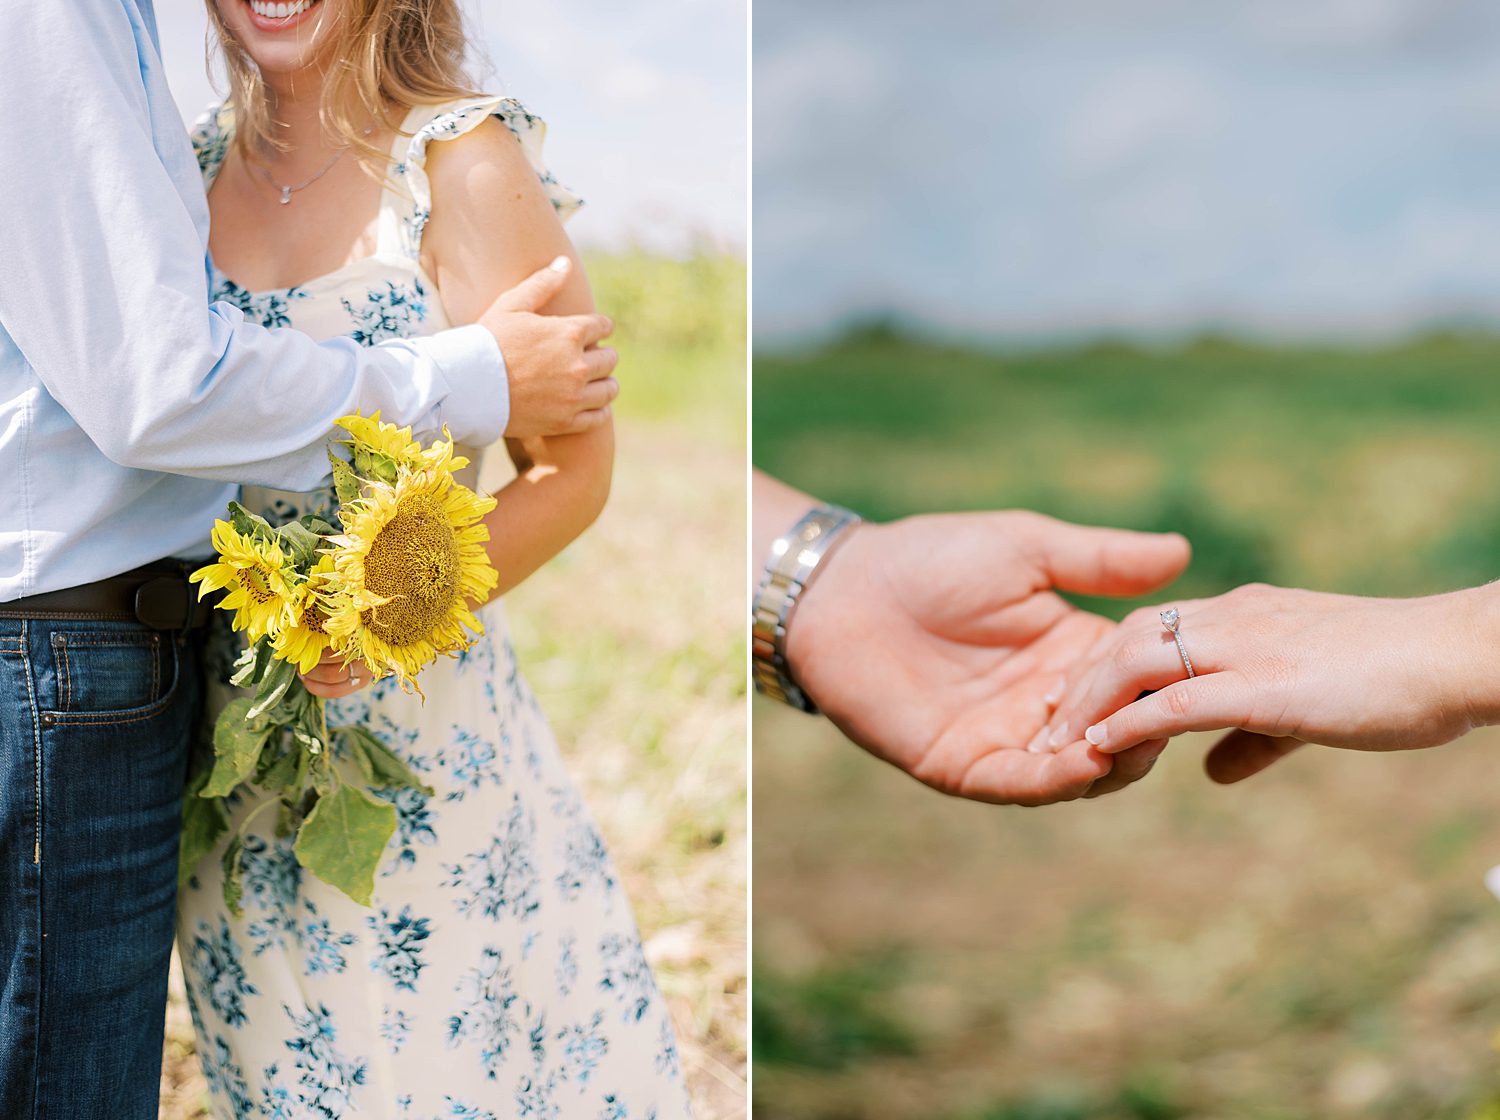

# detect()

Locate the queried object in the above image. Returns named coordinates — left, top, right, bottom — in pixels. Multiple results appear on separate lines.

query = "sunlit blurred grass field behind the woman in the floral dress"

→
left=161, top=255, right=747, bottom=1120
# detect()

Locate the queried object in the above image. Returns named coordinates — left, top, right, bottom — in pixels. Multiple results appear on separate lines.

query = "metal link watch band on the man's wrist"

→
left=750, top=505, right=860, bottom=714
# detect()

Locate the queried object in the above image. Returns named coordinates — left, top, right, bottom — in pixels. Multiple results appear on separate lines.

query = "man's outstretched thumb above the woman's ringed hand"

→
left=1022, top=514, right=1193, bottom=595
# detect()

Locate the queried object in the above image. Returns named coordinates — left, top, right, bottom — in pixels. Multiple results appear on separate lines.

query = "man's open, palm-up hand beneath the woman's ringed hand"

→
left=788, top=513, right=1190, bottom=805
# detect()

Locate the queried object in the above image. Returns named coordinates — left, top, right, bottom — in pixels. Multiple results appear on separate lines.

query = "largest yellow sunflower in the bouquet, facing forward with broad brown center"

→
left=324, top=458, right=500, bottom=688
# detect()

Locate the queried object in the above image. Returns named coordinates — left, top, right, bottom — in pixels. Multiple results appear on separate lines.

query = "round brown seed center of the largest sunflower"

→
left=363, top=495, right=461, bottom=646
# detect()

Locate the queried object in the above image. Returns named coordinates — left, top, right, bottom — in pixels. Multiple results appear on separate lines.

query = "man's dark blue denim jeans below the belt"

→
left=0, top=619, right=203, bottom=1120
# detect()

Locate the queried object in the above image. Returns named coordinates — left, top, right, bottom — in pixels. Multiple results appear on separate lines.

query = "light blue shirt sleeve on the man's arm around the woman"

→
left=0, top=0, right=510, bottom=490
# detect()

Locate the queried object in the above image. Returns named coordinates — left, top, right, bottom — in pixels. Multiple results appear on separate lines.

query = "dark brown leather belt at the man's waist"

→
left=0, top=561, right=213, bottom=630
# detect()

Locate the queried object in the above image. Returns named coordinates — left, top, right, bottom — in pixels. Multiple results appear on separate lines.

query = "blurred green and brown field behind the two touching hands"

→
left=753, top=330, right=1500, bottom=1120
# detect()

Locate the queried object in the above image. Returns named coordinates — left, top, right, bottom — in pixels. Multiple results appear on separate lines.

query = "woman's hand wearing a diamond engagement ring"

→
left=1047, top=586, right=1500, bottom=783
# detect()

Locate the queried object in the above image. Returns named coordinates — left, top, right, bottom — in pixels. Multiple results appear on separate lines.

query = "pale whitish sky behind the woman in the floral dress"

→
left=156, top=0, right=746, bottom=252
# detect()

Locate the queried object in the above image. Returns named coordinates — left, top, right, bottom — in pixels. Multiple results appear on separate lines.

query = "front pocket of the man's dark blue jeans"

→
left=51, top=630, right=179, bottom=723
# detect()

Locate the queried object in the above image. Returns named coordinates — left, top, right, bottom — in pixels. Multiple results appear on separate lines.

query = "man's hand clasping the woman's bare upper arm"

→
left=479, top=256, right=620, bottom=439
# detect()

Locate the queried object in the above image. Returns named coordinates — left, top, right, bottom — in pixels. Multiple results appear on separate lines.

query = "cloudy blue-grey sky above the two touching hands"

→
left=753, top=0, right=1500, bottom=340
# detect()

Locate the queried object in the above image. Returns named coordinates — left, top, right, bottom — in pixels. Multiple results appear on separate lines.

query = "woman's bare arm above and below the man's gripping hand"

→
left=422, top=120, right=615, bottom=595
